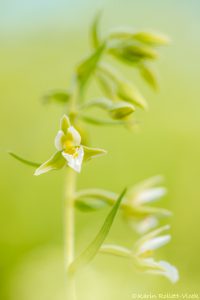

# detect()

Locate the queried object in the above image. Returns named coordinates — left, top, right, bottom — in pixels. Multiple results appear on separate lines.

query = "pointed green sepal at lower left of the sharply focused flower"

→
left=34, top=151, right=66, bottom=176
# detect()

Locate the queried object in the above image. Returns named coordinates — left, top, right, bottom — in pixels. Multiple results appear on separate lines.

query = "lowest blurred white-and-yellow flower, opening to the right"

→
left=134, top=226, right=179, bottom=283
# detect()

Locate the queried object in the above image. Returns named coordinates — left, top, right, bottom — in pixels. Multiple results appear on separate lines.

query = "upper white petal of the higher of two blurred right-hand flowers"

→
left=134, top=187, right=167, bottom=205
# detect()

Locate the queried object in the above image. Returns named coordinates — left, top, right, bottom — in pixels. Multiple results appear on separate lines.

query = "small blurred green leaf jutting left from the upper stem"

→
left=44, top=90, right=72, bottom=104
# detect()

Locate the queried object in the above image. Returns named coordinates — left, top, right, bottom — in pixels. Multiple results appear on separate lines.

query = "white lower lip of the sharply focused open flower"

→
left=62, top=147, right=84, bottom=173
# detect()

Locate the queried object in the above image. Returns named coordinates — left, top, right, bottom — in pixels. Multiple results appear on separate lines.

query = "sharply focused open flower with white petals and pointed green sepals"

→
left=34, top=115, right=106, bottom=176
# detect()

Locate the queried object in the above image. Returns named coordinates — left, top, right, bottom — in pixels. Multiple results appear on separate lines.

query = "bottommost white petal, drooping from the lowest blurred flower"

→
left=144, top=259, right=179, bottom=283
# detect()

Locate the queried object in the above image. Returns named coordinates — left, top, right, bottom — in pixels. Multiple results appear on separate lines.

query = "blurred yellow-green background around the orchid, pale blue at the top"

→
left=0, top=0, right=200, bottom=300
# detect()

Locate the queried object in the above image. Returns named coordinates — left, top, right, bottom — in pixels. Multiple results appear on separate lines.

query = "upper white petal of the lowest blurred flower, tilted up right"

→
left=138, top=234, right=171, bottom=254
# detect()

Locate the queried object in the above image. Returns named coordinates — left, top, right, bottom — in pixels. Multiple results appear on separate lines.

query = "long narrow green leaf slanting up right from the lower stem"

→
left=69, top=189, right=126, bottom=273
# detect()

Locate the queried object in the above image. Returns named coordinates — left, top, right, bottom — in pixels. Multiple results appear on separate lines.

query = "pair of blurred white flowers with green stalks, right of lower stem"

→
left=75, top=176, right=179, bottom=283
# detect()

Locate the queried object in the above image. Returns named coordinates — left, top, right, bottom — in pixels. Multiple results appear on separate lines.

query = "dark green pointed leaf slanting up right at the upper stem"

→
left=77, top=43, right=105, bottom=88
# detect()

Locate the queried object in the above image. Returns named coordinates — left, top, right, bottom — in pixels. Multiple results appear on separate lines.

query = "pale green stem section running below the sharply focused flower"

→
left=64, top=168, right=76, bottom=300
